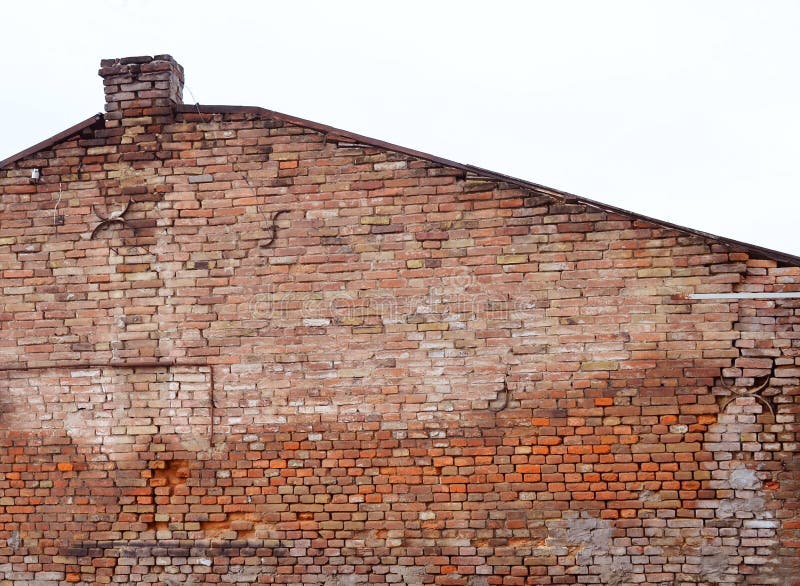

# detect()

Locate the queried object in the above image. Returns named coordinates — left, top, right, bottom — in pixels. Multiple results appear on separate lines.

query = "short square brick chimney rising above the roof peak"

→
left=98, top=55, right=183, bottom=127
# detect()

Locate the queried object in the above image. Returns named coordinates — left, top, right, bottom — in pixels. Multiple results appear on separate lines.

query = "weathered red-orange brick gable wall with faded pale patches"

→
left=0, top=53, right=800, bottom=586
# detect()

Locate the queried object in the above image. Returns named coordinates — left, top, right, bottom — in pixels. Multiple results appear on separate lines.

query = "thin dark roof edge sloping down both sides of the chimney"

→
left=0, top=104, right=800, bottom=266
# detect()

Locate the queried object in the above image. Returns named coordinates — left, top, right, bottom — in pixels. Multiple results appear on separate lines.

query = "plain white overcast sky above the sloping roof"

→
left=0, top=0, right=800, bottom=255
